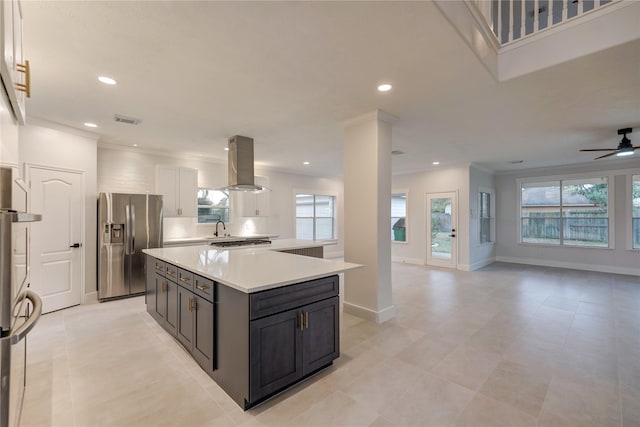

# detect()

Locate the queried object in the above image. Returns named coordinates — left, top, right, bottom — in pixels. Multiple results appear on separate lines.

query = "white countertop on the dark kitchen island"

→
left=143, top=239, right=361, bottom=293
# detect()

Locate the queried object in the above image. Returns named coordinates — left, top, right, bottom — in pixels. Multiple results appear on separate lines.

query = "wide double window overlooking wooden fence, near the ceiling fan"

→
left=520, top=177, right=609, bottom=248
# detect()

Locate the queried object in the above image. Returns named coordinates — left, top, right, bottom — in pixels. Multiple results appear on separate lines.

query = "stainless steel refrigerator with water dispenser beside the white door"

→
left=98, top=193, right=162, bottom=302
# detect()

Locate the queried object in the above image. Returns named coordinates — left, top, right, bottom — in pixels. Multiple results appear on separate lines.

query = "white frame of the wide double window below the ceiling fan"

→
left=516, top=170, right=622, bottom=250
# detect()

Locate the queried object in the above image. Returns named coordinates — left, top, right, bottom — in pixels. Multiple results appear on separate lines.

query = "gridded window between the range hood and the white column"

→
left=296, top=194, right=336, bottom=240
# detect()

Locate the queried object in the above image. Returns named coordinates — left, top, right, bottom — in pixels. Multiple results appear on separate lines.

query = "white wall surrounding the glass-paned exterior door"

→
left=391, top=166, right=471, bottom=270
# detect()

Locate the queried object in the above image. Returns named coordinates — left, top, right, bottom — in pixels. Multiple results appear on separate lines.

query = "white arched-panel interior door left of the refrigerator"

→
left=27, top=166, right=84, bottom=313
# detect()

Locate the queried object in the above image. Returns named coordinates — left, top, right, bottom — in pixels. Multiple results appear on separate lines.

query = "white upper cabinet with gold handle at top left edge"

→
left=0, top=0, right=30, bottom=125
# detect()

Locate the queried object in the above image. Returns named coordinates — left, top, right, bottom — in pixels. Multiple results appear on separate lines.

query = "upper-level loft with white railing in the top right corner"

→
left=435, top=0, right=640, bottom=81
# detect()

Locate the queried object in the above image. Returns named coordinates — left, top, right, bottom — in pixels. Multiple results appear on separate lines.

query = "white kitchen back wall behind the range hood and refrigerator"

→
left=98, top=146, right=343, bottom=256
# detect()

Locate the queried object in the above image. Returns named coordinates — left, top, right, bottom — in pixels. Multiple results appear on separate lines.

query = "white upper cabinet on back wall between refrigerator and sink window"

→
left=156, top=166, right=198, bottom=217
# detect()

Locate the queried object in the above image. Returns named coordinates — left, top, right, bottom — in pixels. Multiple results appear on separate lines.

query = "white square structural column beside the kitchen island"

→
left=344, top=110, right=395, bottom=323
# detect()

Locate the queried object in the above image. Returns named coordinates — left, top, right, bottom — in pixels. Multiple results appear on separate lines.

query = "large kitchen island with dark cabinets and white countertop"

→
left=145, top=239, right=359, bottom=409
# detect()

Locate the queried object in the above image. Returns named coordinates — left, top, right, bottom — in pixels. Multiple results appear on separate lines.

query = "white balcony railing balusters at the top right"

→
left=480, top=0, right=622, bottom=46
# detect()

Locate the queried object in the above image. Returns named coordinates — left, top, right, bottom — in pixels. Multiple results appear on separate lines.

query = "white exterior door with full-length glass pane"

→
left=426, top=192, right=458, bottom=268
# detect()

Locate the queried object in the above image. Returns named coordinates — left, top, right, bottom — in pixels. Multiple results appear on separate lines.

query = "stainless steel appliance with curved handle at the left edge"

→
left=0, top=167, right=42, bottom=427
